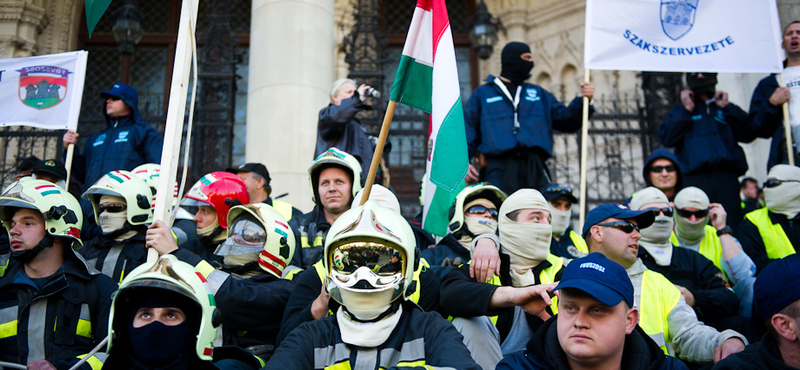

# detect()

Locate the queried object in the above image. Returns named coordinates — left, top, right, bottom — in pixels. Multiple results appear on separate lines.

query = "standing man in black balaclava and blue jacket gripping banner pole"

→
left=464, top=42, right=594, bottom=194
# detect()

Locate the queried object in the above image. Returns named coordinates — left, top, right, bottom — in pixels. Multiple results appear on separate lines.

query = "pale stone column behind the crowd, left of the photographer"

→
left=245, top=0, right=334, bottom=212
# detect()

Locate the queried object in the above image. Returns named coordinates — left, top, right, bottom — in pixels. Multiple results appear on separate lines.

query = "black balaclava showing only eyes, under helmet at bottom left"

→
left=126, top=289, right=201, bottom=368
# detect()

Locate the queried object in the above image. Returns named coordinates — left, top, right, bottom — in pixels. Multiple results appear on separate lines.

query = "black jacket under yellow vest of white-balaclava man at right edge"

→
left=736, top=208, right=800, bottom=276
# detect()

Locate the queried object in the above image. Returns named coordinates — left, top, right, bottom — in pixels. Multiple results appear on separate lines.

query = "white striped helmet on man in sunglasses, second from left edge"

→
left=83, top=171, right=153, bottom=225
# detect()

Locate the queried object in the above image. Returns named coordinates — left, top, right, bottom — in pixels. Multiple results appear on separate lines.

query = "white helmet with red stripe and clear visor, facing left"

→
left=215, top=203, right=295, bottom=278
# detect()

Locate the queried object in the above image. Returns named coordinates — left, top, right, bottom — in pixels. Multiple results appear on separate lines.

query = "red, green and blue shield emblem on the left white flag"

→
left=17, top=66, right=72, bottom=109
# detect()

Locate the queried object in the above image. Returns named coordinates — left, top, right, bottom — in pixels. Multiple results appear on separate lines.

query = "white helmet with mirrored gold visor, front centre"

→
left=323, top=200, right=419, bottom=310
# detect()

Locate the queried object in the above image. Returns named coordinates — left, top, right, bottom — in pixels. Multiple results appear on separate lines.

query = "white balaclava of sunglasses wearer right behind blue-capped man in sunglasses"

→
left=630, top=186, right=675, bottom=266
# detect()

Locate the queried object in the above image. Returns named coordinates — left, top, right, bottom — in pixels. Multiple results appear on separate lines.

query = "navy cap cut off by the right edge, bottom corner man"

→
left=753, top=254, right=800, bottom=321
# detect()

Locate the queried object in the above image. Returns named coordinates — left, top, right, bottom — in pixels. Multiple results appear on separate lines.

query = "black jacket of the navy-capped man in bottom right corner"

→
left=714, top=333, right=796, bottom=370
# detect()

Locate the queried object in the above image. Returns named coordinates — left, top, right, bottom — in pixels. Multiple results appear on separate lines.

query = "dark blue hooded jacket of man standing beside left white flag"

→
left=74, top=84, right=163, bottom=190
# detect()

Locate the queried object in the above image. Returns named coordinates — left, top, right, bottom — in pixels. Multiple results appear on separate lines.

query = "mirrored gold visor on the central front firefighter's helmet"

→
left=330, top=242, right=407, bottom=290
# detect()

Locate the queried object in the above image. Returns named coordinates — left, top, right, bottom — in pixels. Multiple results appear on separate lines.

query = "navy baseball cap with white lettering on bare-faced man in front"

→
left=553, top=252, right=633, bottom=307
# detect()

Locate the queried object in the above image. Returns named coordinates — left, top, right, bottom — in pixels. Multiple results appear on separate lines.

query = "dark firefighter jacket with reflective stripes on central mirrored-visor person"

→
left=264, top=302, right=480, bottom=370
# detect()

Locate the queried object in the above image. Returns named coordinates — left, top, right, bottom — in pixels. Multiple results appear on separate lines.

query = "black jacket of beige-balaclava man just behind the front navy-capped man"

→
left=440, top=253, right=564, bottom=343
